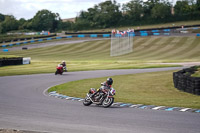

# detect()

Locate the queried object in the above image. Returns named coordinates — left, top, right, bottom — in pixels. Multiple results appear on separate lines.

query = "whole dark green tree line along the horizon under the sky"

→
left=0, top=0, right=200, bottom=33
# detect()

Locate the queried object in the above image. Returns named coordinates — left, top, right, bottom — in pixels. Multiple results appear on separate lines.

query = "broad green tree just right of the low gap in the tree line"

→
left=76, top=0, right=122, bottom=28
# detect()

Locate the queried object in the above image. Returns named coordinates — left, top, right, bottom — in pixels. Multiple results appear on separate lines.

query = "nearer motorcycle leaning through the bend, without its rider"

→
left=83, top=88, right=115, bottom=108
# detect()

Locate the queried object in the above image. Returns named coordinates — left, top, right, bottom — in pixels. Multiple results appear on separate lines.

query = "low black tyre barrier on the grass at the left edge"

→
left=0, top=57, right=23, bottom=67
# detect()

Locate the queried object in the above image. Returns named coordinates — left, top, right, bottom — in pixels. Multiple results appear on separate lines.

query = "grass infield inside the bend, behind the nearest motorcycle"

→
left=48, top=71, right=200, bottom=109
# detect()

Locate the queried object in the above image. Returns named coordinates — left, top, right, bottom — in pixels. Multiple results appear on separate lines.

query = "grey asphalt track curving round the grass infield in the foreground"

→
left=0, top=68, right=200, bottom=133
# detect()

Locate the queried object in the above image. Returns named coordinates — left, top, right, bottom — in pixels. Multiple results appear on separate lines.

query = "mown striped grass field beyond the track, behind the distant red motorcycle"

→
left=0, top=37, right=200, bottom=76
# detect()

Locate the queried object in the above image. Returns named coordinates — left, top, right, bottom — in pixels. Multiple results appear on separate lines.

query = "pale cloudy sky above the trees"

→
left=0, top=0, right=134, bottom=20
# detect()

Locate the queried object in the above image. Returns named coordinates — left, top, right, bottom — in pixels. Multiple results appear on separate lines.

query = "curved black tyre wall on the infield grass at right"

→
left=173, top=66, right=200, bottom=95
